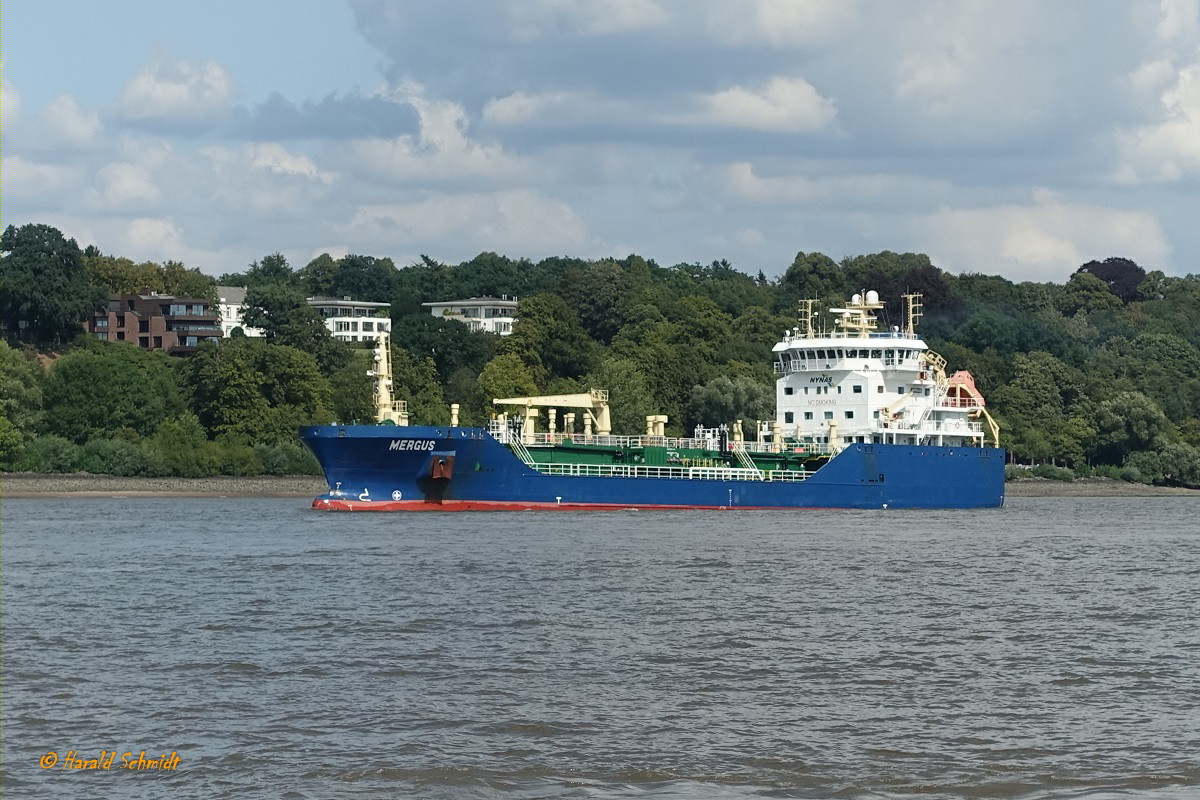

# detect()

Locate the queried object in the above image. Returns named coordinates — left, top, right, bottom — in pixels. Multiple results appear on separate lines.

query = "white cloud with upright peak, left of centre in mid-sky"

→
left=349, top=83, right=520, bottom=180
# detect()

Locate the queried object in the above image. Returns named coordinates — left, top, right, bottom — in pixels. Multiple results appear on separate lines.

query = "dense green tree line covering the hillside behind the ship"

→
left=0, top=225, right=1200, bottom=486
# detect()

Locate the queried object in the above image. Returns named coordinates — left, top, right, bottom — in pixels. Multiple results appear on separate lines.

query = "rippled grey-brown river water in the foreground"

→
left=2, top=498, right=1200, bottom=800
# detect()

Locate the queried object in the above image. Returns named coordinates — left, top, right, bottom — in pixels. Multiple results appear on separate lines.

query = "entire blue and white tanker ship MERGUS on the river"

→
left=300, top=291, right=1004, bottom=511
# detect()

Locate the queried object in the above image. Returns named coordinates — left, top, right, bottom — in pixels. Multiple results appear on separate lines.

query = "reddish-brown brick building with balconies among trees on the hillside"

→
left=84, top=291, right=221, bottom=355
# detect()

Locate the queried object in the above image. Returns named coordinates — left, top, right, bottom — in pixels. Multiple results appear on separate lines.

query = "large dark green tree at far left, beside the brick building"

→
left=0, top=224, right=106, bottom=347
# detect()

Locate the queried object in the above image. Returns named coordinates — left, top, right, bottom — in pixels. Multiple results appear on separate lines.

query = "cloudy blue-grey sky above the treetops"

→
left=0, top=0, right=1200, bottom=283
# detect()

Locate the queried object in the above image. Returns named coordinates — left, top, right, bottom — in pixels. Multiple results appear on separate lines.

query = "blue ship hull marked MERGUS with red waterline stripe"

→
left=300, top=425, right=1004, bottom=511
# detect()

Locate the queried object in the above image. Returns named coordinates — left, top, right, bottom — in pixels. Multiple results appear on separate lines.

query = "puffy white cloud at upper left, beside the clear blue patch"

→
left=118, top=61, right=234, bottom=124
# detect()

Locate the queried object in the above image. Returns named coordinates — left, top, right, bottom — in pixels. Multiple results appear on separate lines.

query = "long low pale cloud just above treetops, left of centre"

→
left=346, top=190, right=588, bottom=257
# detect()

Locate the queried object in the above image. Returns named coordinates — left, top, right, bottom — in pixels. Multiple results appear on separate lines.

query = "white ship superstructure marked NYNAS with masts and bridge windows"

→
left=774, top=291, right=998, bottom=450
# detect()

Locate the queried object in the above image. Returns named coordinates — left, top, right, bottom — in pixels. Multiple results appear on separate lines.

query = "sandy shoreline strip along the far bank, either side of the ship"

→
left=0, top=473, right=1200, bottom=498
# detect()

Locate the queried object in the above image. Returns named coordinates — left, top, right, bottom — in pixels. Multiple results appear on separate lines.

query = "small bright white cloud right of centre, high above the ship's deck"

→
left=674, top=77, right=838, bottom=133
